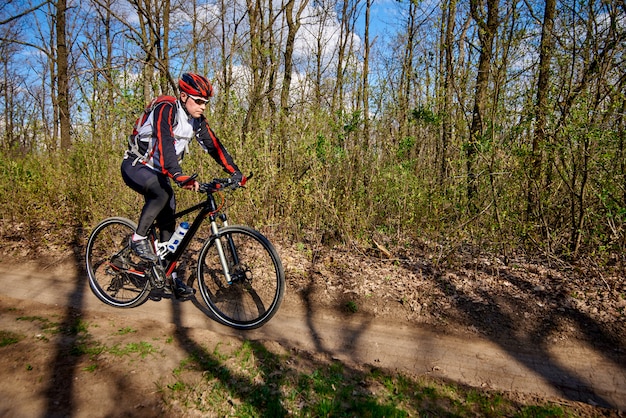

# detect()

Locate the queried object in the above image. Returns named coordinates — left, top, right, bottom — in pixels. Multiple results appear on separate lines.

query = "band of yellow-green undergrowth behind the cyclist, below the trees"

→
left=0, top=101, right=626, bottom=262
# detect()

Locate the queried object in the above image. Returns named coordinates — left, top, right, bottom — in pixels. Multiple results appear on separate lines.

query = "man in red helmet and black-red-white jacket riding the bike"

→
left=121, top=73, right=245, bottom=297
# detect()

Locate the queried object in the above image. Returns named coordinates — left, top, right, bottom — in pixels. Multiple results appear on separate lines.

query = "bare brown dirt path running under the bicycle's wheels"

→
left=0, top=263, right=626, bottom=416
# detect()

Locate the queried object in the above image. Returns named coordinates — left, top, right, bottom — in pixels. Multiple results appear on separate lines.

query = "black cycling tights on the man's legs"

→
left=121, top=159, right=176, bottom=242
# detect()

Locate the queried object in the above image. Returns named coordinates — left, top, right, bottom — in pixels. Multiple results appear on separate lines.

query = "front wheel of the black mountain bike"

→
left=197, top=225, right=285, bottom=330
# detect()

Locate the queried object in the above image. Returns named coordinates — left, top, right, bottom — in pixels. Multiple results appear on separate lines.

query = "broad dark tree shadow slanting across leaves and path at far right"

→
left=407, top=256, right=626, bottom=408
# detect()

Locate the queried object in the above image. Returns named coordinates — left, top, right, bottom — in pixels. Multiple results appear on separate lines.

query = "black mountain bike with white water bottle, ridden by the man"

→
left=85, top=175, right=285, bottom=330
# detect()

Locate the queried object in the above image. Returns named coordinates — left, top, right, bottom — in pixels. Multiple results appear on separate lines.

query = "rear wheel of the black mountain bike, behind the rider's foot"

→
left=85, top=217, right=151, bottom=308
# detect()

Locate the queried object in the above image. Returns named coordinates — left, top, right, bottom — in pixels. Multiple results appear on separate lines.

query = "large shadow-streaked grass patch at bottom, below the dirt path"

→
left=157, top=341, right=574, bottom=417
